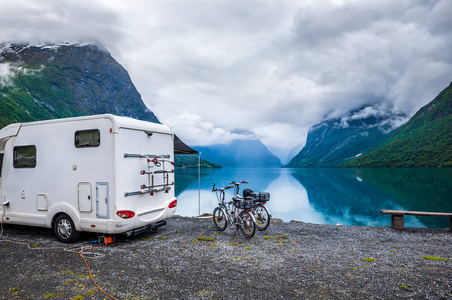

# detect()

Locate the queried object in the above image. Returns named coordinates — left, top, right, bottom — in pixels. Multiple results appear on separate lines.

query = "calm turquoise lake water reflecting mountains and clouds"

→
left=176, top=168, right=452, bottom=228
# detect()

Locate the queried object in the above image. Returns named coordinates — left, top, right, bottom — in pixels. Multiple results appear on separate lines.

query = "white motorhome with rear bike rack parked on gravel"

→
left=0, top=114, right=177, bottom=242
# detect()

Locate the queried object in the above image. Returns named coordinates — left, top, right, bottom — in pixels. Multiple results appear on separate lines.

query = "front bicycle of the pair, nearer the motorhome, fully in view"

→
left=212, top=183, right=256, bottom=238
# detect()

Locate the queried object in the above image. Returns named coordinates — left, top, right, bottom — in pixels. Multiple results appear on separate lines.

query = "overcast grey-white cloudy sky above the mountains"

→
left=0, top=0, right=452, bottom=159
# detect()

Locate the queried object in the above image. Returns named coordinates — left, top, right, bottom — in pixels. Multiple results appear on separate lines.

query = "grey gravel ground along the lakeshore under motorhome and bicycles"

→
left=0, top=217, right=452, bottom=299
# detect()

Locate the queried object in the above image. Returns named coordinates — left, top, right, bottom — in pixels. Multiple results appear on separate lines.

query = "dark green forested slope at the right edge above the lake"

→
left=342, top=83, right=452, bottom=167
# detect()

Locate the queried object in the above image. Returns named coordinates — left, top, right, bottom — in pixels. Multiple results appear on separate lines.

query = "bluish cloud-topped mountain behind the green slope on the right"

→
left=287, top=106, right=406, bottom=168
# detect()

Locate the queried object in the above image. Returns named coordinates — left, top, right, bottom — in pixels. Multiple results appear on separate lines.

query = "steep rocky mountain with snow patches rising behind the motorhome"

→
left=0, top=43, right=159, bottom=127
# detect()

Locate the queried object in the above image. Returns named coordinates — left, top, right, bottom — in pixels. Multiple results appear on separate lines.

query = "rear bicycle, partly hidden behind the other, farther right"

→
left=229, top=180, right=271, bottom=231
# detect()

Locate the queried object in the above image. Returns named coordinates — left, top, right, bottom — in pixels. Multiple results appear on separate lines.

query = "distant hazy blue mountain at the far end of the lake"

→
left=193, top=140, right=281, bottom=168
